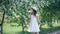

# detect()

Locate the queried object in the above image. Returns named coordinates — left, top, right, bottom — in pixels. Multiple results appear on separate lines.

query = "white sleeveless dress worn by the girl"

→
left=28, top=14, right=40, bottom=32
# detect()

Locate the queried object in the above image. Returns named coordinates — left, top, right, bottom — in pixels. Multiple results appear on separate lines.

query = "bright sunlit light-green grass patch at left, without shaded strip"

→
left=3, top=23, right=22, bottom=34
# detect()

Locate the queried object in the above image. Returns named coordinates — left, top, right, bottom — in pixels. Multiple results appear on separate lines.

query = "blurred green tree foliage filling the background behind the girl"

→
left=0, top=0, right=60, bottom=33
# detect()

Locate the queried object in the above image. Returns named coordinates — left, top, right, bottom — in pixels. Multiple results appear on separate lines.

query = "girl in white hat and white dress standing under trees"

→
left=28, top=7, right=40, bottom=34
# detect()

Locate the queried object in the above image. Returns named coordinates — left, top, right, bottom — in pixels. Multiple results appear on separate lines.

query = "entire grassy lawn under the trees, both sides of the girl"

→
left=3, top=23, right=60, bottom=34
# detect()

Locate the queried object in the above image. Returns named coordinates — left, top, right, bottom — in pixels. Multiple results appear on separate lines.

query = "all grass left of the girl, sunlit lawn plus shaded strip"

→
left=3, top=23, right=31, bottom=34
